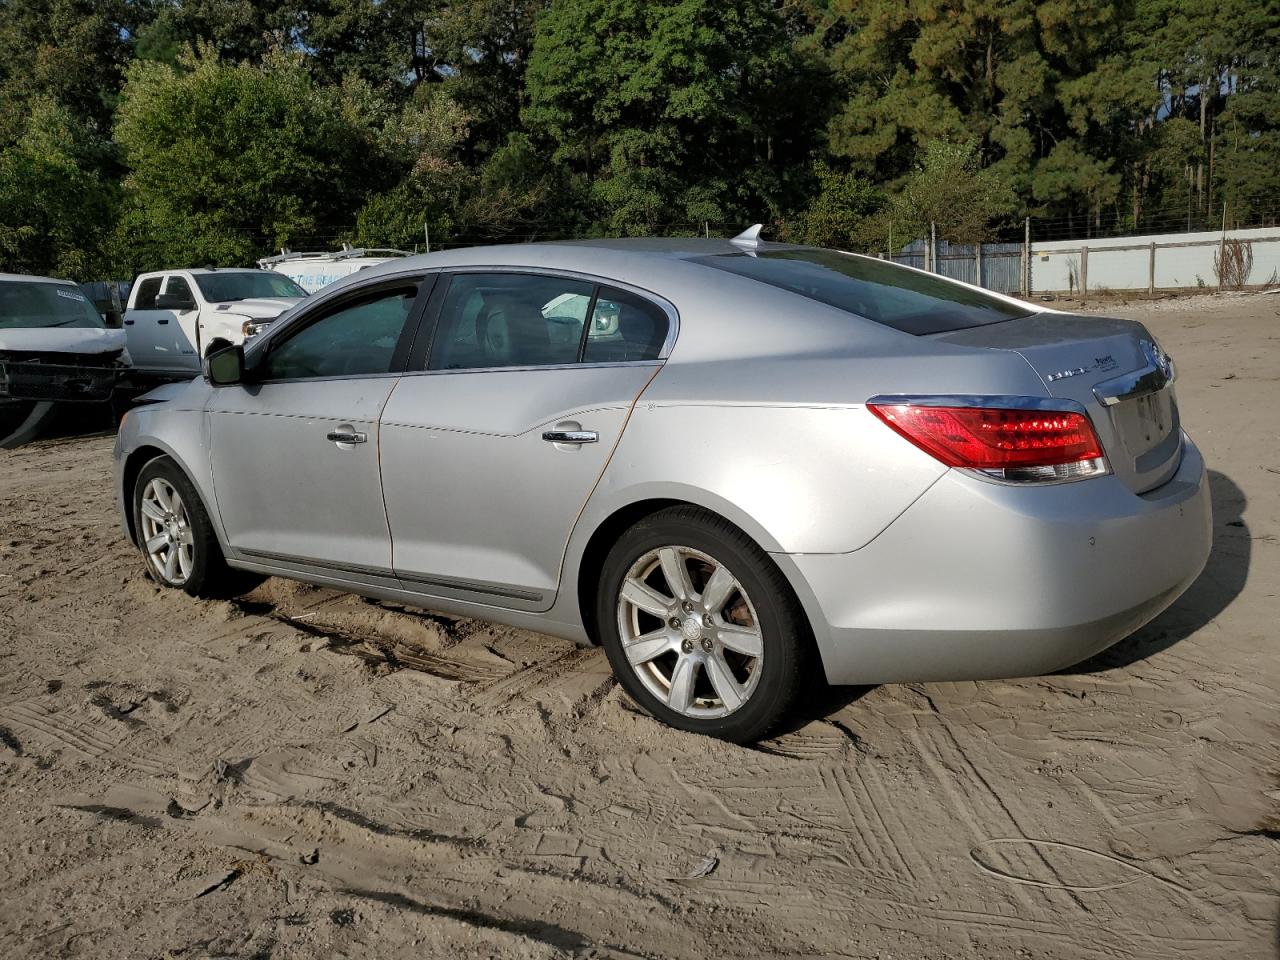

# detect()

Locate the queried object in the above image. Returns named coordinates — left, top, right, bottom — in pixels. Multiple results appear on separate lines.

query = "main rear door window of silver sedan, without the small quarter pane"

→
left=428, top=273, right=593, bottom=370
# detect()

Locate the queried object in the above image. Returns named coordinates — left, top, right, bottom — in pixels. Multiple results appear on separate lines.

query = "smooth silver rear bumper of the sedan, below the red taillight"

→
left=776, top=439, right=1212, bottom=684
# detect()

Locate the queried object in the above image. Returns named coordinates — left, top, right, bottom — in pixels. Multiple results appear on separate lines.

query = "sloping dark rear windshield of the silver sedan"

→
left=694, top=250, right=1032, bottom=337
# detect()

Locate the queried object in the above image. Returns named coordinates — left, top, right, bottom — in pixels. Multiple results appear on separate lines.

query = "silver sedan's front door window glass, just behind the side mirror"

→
left=261, top=283, right=417, bottom=380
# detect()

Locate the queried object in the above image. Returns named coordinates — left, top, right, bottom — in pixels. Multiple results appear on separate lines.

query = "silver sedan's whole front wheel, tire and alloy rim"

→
left=133, top=457, right=233, bottom=596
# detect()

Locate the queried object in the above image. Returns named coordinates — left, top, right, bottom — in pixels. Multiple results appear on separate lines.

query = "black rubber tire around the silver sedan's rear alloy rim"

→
left=595, top=506, right=814, bottom=744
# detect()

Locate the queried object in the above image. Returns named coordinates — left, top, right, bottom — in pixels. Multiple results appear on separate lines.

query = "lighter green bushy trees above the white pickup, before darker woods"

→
left=107, top=47, right=463, bottom=272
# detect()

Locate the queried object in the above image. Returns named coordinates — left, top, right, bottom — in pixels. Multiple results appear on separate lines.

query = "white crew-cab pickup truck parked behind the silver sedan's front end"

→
left=124, top=269, right=307, bottom=378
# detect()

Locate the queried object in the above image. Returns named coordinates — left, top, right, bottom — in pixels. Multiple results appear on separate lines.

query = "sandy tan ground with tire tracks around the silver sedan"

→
left=0, top=297, right=1280, bottom=960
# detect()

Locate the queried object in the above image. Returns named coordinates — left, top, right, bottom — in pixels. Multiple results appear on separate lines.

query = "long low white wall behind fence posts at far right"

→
left=1030, top=227, right=1280, bottom=293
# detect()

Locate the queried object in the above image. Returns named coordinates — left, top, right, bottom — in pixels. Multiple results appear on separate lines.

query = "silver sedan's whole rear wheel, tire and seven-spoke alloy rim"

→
left=596, top=507, right=812, bottom=742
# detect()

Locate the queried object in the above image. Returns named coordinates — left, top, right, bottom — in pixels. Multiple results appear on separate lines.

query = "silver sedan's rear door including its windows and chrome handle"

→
left=380, top=271, right=675, bottom=609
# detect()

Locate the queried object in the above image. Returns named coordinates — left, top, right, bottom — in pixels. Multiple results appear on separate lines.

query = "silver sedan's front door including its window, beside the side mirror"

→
left=207, top=279, right=430, bottom=581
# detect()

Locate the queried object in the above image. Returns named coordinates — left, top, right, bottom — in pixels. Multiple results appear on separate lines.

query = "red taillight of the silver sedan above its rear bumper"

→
left=868, top=402, right=1106, bottom=480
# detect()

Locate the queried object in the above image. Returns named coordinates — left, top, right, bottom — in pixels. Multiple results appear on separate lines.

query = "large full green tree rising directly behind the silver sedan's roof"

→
left=524, top=0, right=810, bottom=232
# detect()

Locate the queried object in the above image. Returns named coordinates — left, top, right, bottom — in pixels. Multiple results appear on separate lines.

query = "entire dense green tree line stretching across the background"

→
left=0, top=0, right=1280, bottom=279
